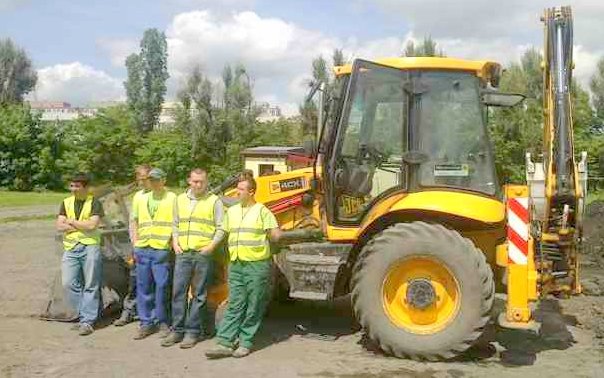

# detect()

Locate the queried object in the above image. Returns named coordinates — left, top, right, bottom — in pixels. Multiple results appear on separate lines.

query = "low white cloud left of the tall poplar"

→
left=28, top=62, right=124, bottom=105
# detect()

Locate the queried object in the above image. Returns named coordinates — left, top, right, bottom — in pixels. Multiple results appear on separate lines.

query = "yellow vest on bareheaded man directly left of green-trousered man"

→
left=177, top=193, right=218, bottom=251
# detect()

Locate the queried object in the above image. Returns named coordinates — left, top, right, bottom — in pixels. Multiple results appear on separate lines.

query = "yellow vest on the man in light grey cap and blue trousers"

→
left=134, top=192, right=176, bottom=249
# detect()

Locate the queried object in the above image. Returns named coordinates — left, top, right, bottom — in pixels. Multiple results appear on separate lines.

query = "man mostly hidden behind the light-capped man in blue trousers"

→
left=113, top=164, right=151, bottom=327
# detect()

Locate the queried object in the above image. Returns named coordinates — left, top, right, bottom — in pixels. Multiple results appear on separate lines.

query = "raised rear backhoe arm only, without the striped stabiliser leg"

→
left=529, top=7, right=585, bottom=295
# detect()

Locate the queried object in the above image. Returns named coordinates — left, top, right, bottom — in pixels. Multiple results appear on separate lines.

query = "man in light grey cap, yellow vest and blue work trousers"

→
left=131, top=168, right=176, bottom=340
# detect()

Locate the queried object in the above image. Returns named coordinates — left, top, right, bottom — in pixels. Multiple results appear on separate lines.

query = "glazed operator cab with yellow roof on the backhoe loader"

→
left=323, top=58, right=510, bottom=224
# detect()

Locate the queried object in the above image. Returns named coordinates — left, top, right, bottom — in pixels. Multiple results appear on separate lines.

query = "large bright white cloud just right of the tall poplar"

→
left=167, top=11, right=342, bottom=115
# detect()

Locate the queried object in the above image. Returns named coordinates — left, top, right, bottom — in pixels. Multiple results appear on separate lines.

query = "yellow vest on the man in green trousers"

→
left=227, top=203, right=271, bottom=261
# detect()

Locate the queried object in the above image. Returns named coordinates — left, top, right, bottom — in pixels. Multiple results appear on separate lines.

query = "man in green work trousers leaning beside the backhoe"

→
left=206, top=175, right=282, bottom=358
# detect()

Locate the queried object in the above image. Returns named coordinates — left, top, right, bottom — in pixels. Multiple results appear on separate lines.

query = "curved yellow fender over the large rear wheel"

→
left=390, top=190, right=505, bottom=223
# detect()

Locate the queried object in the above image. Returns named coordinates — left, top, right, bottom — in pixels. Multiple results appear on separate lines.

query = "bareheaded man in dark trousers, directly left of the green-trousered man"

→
left=161, top=168, right=225, bottom=349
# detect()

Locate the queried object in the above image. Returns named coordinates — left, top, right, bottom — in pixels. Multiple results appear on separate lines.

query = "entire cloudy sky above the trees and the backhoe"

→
left=0, top=0, right=604, bottom=114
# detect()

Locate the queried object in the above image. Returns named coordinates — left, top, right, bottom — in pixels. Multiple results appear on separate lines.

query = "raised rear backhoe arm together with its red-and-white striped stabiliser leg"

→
left=498, top=7, right=587, bottom=329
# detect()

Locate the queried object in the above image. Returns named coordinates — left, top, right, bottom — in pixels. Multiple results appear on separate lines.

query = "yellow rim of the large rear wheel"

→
left=382, top=256, right=461, bottom=335
